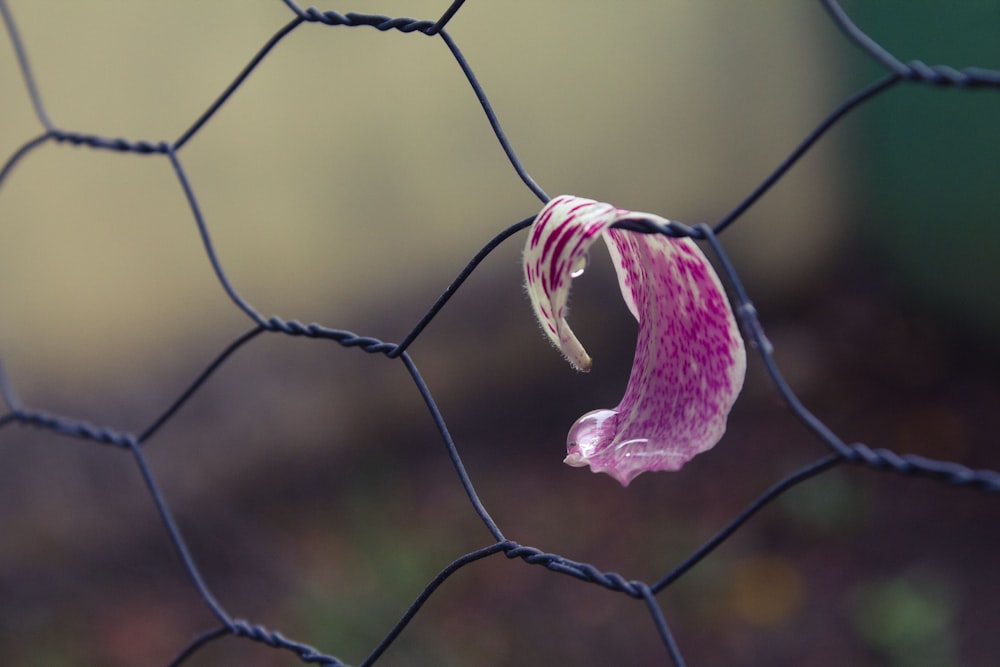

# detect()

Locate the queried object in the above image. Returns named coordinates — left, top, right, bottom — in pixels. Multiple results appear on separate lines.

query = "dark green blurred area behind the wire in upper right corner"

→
left=851, top=0, right=1000, bottom=339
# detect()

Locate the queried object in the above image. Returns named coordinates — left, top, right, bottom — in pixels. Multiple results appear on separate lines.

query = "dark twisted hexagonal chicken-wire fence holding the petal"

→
left=0, top=0, right=1000, bottom=667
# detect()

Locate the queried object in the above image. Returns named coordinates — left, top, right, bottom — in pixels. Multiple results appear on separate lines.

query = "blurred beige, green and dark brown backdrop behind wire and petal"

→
left=0, top=0, right=1000, bottom=667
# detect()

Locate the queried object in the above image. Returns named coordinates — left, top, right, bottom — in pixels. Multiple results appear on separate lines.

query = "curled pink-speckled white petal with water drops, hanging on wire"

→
left=524, top=195, right=746, bottom=486
